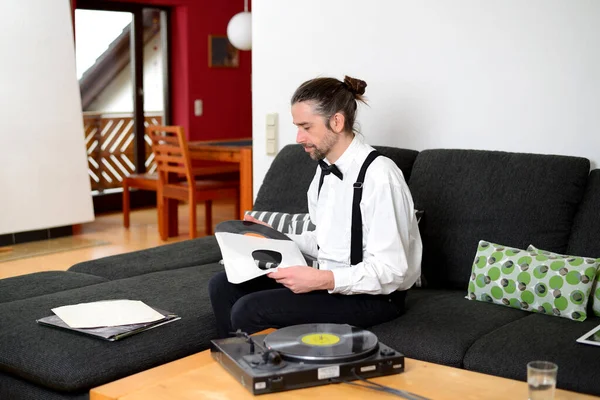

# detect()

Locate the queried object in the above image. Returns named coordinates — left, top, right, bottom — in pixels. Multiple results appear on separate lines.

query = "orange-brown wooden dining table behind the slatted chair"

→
left=166, top=138, right=254, bottom=237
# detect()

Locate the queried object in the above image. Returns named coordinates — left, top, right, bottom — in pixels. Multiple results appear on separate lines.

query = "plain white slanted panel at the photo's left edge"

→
left=0, top=0, right=94, bottom=234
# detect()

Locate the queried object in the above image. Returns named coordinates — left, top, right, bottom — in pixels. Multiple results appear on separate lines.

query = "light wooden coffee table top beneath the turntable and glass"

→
left=90, top=330, right=597, bottom=400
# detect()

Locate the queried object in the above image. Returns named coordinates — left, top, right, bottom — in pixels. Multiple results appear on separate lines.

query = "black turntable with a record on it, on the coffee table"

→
left=211, top=324, right=404, bottom=395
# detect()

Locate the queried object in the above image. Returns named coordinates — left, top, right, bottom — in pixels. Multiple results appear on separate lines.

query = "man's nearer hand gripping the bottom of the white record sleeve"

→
left=267, top=266, right=335, bottom=293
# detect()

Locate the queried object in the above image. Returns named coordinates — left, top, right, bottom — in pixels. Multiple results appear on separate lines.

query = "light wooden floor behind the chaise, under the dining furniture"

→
left=0, top=200, right=238, bottom=279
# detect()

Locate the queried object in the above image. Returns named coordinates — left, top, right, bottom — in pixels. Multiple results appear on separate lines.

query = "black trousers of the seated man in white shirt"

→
left=208, top=272, right=406, bottom=338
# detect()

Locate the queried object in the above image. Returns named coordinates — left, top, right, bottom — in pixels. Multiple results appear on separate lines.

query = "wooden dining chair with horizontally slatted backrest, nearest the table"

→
left=146, top=126, right=240, bottom=240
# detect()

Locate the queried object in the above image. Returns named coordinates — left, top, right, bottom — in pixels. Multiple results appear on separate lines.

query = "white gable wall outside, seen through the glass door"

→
left=86, top=35, right=164, bottom=112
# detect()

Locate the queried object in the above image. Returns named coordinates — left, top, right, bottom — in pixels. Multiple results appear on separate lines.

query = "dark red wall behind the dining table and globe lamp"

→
left=73, top=0, right=252, bottom=140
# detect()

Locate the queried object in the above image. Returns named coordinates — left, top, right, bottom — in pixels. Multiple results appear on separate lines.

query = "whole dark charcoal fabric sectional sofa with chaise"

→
left=0, top=145, right=600, bottom=400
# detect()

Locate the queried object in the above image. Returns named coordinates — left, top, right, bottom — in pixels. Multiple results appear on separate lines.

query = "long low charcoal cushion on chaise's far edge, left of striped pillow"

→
left=69, top=236, right=221, bottom=280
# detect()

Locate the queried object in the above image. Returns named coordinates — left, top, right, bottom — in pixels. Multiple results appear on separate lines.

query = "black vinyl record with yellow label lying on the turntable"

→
left=264, top=324, right=379, bottom=364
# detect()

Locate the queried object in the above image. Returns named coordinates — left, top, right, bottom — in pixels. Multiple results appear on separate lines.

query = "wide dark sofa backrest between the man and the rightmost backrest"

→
left=409, top=150, right=590, bottom=290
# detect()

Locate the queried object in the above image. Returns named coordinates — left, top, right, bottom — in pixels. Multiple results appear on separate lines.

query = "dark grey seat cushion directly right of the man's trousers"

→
left=370, top=289, right=528, bottom=367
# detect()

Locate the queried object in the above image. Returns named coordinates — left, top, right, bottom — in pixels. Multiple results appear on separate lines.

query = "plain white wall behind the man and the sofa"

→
left=252, top=0, right=600, bottom=198
